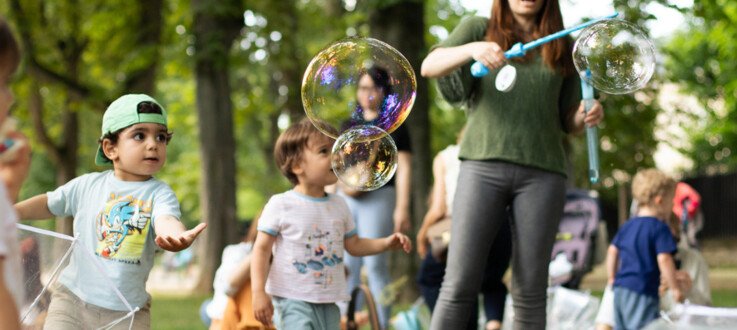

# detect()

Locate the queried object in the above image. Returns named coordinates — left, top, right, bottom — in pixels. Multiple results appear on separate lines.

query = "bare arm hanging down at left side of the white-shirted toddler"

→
left=251, top=232, right=276, bottom=326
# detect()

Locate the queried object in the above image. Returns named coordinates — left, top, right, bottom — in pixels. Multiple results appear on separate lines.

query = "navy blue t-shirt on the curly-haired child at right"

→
left=612, top=217, right=677, bottom=298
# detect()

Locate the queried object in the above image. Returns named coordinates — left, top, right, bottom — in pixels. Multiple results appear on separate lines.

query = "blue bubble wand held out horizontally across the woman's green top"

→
left=471, top=12, right=619, bottom=83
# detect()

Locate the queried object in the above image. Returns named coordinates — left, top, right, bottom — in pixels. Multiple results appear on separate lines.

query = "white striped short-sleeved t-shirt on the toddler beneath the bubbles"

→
left=258, top=190, right=356, bottom=303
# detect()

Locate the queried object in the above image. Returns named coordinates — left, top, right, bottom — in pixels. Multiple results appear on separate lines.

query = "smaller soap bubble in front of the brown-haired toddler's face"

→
left=332, top=125, right=397, bottom=191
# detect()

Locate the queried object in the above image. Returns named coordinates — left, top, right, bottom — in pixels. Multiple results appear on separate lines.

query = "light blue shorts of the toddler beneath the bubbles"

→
left=271, top=297, right=340, bottom=330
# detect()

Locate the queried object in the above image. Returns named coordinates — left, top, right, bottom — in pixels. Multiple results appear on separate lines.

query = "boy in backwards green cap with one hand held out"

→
left=15, top=94, right=205, bottom=329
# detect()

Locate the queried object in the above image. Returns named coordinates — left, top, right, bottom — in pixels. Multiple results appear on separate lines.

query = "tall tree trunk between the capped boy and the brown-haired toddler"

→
left=192, top=0, right=243, bottom=291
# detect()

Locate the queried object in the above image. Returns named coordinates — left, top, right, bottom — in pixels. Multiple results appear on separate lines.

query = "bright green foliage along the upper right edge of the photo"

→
left=663, top=0, right=737, bottom=175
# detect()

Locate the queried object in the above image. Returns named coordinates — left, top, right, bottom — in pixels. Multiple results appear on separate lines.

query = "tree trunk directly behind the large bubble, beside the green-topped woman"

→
left=369, top=0, right=432, bottom=300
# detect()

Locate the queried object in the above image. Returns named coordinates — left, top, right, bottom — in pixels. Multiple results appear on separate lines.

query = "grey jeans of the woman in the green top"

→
left=431, top=161, right=565, bottom=330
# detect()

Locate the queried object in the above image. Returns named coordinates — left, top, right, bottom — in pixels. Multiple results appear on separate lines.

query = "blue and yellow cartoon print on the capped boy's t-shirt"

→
left=95, top=194, right=152, bottom=264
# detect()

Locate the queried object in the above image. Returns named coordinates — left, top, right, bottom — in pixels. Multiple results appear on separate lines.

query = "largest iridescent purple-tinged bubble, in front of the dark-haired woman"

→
left=302, top=37, right=417, bottom=138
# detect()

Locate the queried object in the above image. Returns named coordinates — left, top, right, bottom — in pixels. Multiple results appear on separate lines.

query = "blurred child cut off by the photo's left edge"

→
left=0, top=17, right=30, bottom=329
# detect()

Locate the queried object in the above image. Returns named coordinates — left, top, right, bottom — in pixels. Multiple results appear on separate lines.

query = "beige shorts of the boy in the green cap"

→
left=44, top=285, right=151, bottom=330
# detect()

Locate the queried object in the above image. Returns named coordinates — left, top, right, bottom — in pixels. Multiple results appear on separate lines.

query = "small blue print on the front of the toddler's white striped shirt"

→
left=292, top=225, right=343, bottom=288
